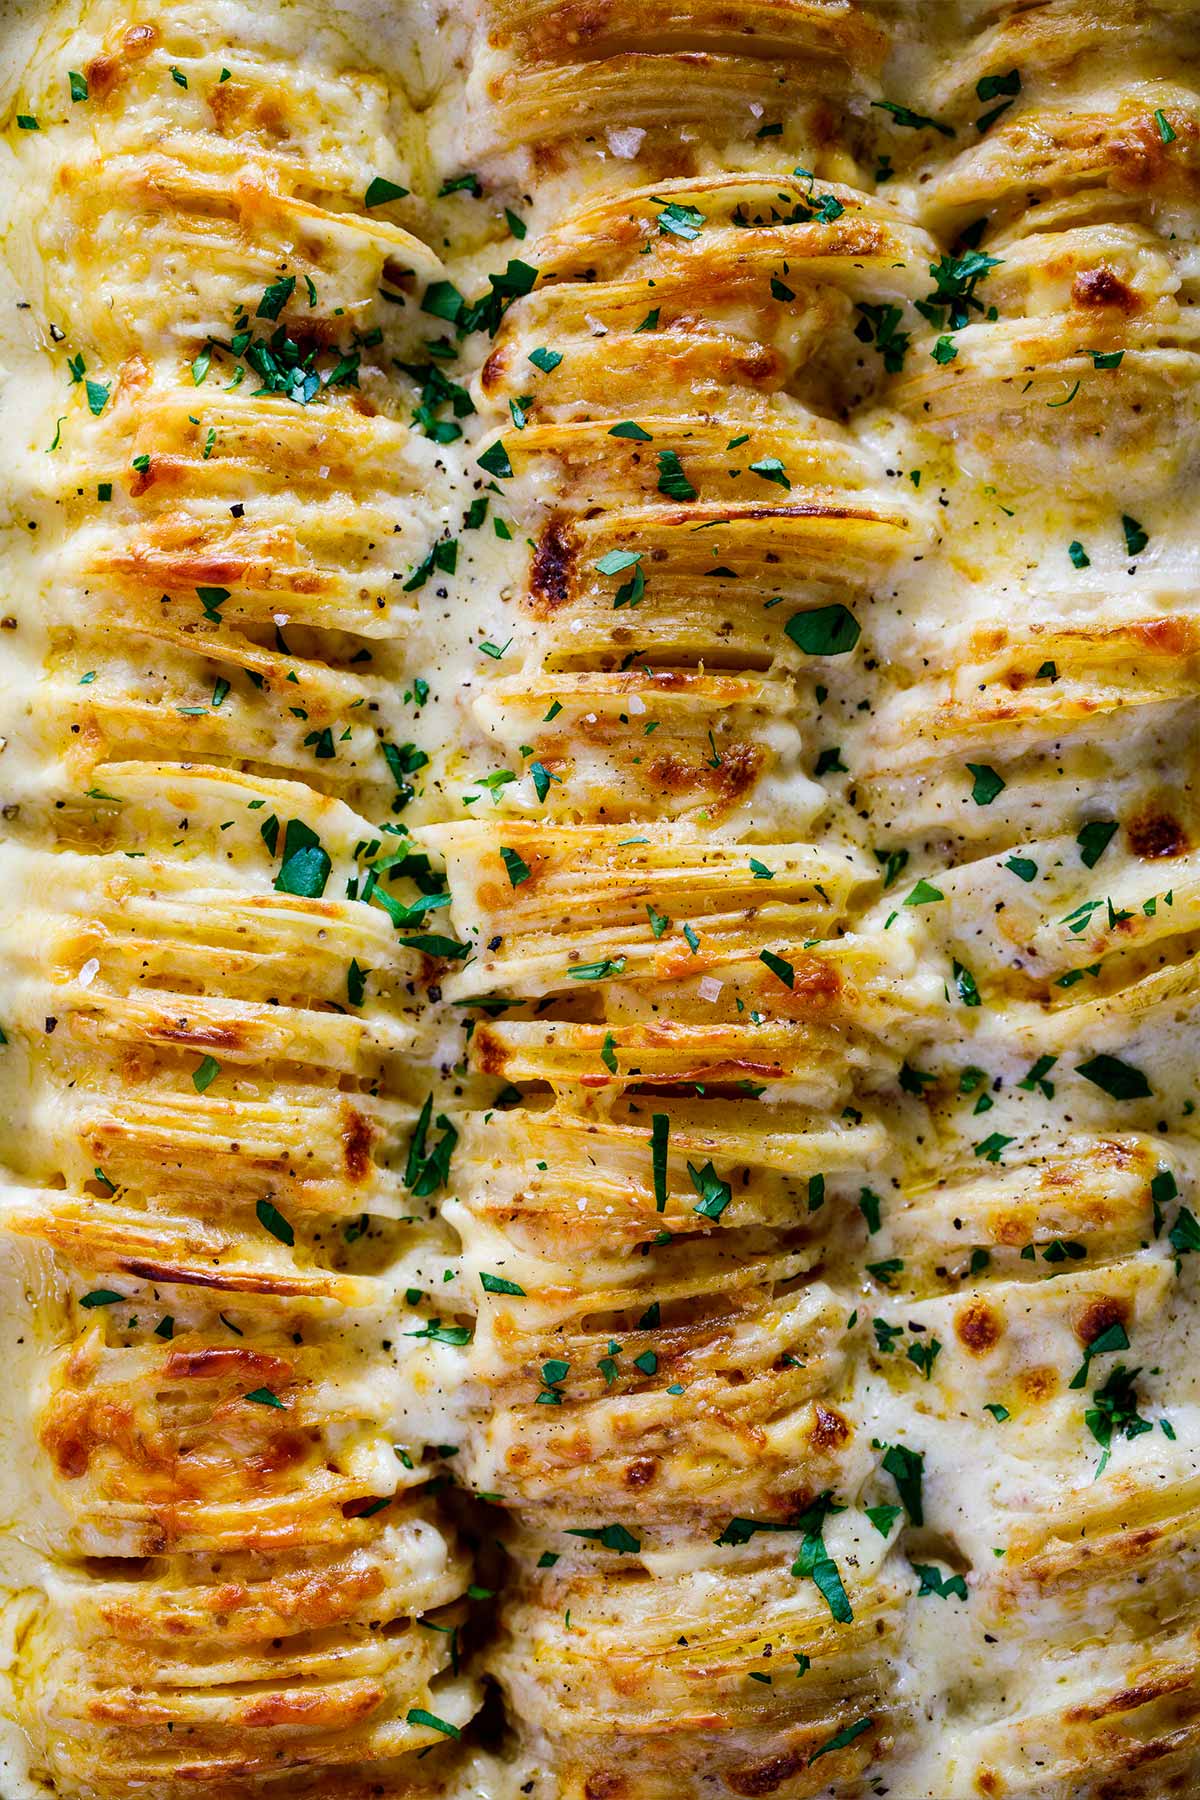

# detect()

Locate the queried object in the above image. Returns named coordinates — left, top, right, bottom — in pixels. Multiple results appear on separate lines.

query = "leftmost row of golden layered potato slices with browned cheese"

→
left=0, top=0, right=480, bottom=1800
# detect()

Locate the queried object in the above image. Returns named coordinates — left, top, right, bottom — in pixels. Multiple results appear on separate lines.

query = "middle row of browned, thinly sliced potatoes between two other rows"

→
left=425, top=5, right=941, bottom=1800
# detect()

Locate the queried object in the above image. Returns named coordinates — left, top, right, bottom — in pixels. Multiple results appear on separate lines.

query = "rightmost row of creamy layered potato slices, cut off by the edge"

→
left=860, top=4, right=1200, bottom=1796
